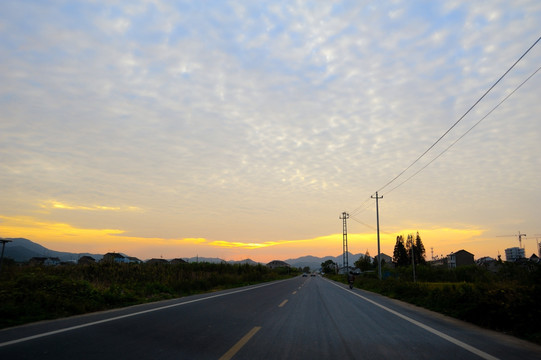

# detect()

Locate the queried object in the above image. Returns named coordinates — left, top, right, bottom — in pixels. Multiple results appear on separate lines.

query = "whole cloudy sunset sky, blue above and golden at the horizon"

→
left=0, top=0, right=541, bottom=262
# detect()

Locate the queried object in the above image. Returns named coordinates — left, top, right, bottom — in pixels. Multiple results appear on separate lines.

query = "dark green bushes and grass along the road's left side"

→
left=0, top=263, right=296, bottom=328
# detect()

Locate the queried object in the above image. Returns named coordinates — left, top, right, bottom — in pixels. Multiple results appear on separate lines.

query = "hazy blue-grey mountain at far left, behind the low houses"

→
left=4, top=238, right=103, bottom=262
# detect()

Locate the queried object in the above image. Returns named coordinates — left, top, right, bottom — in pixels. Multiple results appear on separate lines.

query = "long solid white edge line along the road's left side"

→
left=0, top=280, right=288, bottom=348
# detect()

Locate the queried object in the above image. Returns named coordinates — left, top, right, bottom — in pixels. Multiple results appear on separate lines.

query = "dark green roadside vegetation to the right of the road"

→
left=333, top=263, right=541, bottom=344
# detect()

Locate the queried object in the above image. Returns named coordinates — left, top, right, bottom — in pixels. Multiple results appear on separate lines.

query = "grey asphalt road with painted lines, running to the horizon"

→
left=0, top=276, right=541, bottom=360
